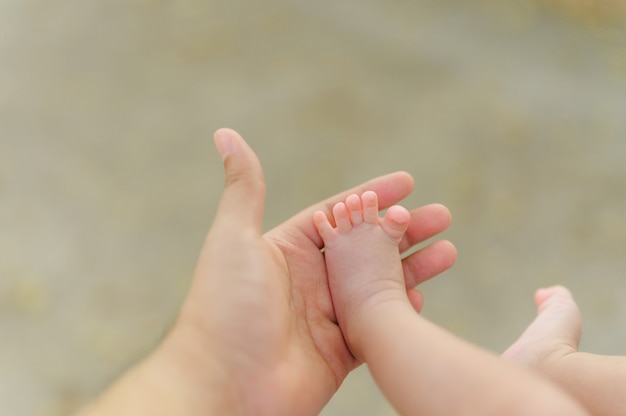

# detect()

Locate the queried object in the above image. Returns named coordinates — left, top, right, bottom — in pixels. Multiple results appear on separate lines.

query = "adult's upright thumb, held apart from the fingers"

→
left=214, top=128, right=265, bottom=232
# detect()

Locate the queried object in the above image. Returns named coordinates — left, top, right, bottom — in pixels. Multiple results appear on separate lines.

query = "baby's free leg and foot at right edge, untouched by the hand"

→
left=503, top=286, right=626, bottom=416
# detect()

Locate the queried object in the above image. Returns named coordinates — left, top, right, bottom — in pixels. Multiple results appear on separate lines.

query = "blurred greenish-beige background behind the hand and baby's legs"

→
left=0, top=0, right=626, bottom=416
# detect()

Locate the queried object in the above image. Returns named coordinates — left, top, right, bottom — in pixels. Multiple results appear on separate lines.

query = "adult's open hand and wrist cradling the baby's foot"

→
left=84, top=129, right=456, bottom=416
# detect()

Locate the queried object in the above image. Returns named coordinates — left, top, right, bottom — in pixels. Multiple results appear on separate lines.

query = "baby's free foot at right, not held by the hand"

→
left=502, top=286, right=581, bottom=371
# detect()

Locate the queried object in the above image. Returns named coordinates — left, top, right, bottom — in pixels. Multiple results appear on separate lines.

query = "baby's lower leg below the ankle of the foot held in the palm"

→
left=354, top=302, right=584, bottom=416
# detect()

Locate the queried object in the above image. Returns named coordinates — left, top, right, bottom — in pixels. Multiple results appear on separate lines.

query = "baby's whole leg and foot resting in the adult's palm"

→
left=314, top=192, right=588, bottom=416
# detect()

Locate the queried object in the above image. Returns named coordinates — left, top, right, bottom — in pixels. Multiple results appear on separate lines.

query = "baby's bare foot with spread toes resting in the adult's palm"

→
left=314, top=191, right=411, bottom=352
